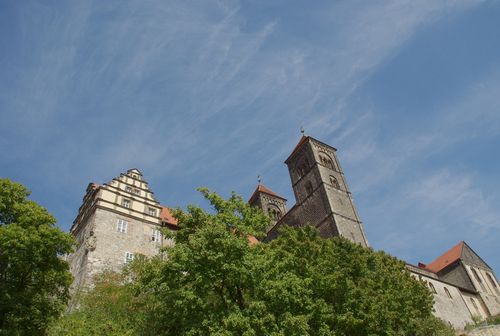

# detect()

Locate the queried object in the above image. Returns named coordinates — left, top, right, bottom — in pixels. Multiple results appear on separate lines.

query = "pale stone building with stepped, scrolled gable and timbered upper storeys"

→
left=68, top=169, right=177, bottom=290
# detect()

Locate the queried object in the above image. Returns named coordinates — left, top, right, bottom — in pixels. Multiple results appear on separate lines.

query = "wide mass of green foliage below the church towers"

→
left=49, top=190, right=453, bottom=336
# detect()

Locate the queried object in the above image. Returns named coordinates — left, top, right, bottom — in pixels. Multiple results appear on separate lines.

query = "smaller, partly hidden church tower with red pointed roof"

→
left=248, top=183, right=287, bottom=225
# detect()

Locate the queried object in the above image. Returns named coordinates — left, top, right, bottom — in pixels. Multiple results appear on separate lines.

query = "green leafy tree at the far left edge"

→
left=0, top=179, right=73, bottom=335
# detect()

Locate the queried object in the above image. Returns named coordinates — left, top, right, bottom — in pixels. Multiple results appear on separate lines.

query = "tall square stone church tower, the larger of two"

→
left=269, top=136, right=369, bottom=246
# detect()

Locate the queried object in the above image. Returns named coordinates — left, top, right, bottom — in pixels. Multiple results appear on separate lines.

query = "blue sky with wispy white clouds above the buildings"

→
left=0, top=0, right=500, bottom=272
